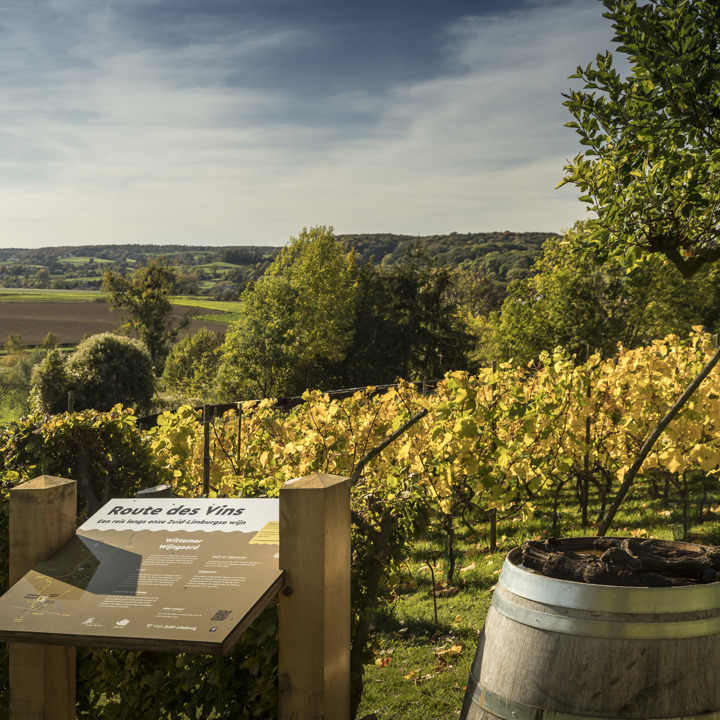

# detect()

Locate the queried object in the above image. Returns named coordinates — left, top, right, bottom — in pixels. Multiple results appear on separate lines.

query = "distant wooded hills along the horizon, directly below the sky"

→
left=0, top=231, right=557, bottom=300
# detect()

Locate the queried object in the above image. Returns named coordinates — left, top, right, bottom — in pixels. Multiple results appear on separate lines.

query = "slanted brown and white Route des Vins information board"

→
left=0, top=498, right=282, bottom=654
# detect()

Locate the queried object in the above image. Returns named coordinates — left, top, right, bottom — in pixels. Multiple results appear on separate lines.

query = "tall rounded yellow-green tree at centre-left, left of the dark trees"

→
left=219, top=226, right=357, bottom=398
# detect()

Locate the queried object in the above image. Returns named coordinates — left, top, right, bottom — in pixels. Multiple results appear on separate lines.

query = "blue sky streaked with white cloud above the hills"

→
left=0, top=0, right=612, bottom=247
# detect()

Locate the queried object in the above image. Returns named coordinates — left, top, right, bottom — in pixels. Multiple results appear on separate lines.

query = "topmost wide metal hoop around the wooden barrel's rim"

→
left=498, top=551, right=720, bottom=615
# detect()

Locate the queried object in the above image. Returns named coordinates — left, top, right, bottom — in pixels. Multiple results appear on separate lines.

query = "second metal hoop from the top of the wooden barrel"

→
left=492, top=592, right=720, bottom=640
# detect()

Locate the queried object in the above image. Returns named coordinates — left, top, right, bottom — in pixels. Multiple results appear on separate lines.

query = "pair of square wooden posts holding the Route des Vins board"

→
left=2, top=473, right=351, bottom=720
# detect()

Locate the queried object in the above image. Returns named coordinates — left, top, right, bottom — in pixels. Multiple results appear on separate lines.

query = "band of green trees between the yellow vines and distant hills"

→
left=12, top=224, right=720, bottom=412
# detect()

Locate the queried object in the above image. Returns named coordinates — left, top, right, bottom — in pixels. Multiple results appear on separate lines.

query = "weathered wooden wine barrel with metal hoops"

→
left=461, top=538, right=720, bottom=720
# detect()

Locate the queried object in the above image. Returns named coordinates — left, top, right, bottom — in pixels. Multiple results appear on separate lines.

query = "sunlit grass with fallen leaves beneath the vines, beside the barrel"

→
left=358, top=472, right=720, bottom=720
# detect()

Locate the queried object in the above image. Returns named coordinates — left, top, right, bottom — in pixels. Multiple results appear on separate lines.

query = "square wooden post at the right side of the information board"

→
left=278, top=473, right=351, bottom=720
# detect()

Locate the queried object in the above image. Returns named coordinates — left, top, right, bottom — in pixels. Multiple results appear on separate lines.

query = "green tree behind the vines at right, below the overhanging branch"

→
left=486, top=223, right=720, bottom=363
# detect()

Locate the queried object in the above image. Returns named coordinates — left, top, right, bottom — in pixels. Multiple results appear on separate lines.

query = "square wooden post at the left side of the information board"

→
left=8, top=475, right=77, bottom=720
